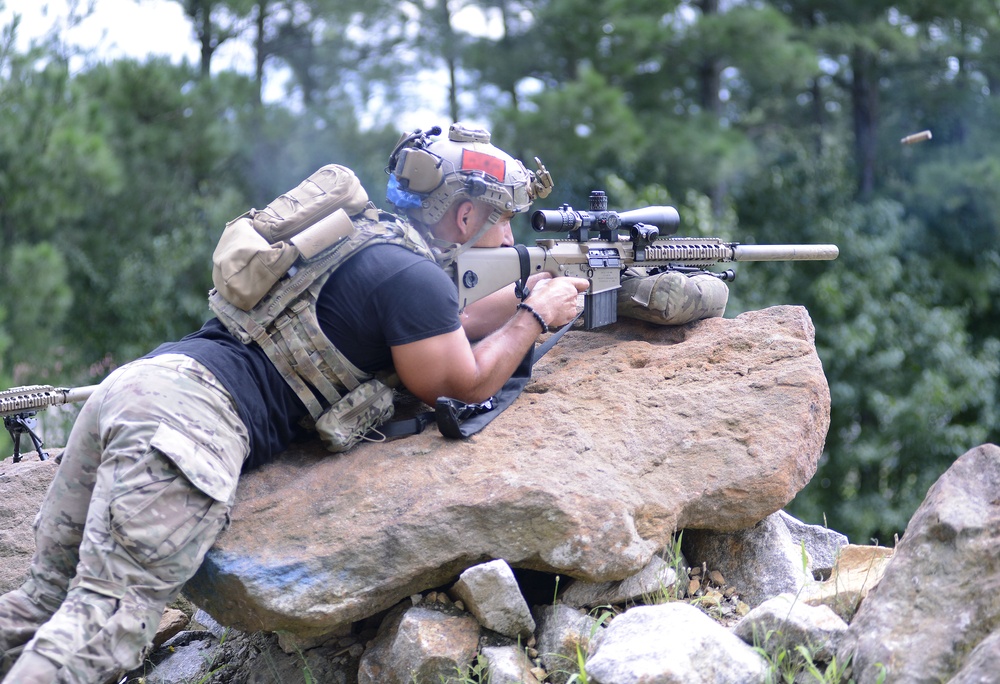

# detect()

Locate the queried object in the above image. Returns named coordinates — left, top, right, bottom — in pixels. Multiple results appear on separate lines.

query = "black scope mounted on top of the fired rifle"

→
left=531, top=191, right=681, bottom=236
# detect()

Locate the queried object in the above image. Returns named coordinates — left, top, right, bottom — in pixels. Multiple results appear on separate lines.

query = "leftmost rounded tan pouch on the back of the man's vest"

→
left=212, top=216, right=299, bottom=311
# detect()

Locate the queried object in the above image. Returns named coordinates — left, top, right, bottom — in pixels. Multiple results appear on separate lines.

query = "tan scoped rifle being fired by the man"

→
left=452, top=190, right=839, bottom=330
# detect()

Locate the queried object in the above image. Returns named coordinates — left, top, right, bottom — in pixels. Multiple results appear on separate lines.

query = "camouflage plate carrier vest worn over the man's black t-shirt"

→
left=209, top=164, right=434, bottom=451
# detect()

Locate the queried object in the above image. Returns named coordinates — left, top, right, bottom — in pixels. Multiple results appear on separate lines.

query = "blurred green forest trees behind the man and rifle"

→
left=0, top=0, right=1000, bottom=543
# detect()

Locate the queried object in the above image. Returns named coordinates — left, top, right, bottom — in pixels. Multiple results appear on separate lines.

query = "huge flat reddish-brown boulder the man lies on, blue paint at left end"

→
left=187, top=306, right=830, bottom=634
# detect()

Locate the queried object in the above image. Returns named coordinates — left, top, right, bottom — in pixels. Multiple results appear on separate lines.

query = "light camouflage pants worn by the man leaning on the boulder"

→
left=0, top=355, right=249, bottom=684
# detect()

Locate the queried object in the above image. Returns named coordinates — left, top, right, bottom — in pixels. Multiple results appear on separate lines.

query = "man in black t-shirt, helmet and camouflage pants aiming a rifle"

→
left=0, top=124, right=740, bottom=684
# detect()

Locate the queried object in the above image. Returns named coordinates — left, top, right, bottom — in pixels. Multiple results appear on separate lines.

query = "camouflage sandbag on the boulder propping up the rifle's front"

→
left=618, top=271, right=729, bottom=325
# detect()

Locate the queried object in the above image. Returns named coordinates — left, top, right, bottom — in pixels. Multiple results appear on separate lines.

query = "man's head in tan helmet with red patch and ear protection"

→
left=386, top=123, right=552, bottom=246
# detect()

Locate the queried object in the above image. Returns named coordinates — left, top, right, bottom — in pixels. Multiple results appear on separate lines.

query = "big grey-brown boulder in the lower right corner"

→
left=838, top=444, right=1000, bottom=684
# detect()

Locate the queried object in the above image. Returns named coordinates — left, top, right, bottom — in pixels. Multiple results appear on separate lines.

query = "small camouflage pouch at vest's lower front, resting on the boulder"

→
left=316, top=380, right=395, bottom=453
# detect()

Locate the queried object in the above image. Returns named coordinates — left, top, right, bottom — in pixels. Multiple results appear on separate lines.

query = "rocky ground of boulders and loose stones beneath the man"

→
left=0, top=307, right=1000, bottom=684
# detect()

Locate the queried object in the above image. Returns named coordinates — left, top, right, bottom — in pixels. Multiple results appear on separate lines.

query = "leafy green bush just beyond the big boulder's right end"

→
left=794, top=195, right=1000, bottom=543
